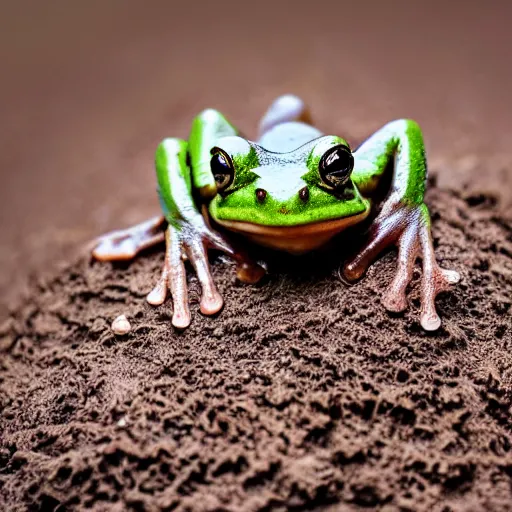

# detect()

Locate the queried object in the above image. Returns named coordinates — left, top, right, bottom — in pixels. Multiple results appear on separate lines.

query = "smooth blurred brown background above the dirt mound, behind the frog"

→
left=0, top=0, right=512, bottom=315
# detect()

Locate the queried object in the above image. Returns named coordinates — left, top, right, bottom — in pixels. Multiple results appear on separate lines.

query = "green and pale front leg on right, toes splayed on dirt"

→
left=345, top=120, right=459, bottom=331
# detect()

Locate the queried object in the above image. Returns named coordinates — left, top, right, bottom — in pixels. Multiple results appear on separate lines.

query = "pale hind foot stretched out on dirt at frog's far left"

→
left=92, top=215, right=167, bottom=261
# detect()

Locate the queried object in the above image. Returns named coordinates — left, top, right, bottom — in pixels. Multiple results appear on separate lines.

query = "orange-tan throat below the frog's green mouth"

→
left=215, top=209, right=370, bottom=254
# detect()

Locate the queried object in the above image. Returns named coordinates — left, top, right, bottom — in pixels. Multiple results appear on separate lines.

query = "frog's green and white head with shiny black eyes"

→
left=209, top=136, right=370, bottom=252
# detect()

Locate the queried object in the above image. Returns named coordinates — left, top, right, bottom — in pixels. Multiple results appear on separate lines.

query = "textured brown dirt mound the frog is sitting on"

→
left=0, top=188, right=512, bottom=511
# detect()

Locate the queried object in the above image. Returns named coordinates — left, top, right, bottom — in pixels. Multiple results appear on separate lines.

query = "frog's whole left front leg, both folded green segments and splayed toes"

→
left=148, top=109, right=265, bottom=328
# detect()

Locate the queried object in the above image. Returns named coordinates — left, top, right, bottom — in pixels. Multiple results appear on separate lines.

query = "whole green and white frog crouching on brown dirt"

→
left=92, top=94, right=460, bottom=331
